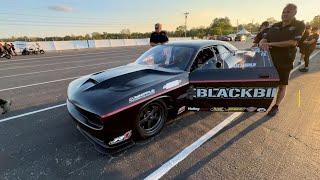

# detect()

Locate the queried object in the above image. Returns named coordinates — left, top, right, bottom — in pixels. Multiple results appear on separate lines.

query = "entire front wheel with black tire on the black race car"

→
left=135, top=100, right=168, bottom=139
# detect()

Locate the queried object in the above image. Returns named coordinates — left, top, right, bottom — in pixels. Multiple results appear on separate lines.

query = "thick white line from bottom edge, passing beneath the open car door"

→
left=145, top=51, right=320, bottom=180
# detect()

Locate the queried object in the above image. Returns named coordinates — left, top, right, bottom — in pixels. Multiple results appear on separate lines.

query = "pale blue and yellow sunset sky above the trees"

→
left=0, top=0, right=320, bottom=38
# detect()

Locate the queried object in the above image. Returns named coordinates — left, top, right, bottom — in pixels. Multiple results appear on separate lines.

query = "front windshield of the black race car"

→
left=135, top=45, right=194, bottom=70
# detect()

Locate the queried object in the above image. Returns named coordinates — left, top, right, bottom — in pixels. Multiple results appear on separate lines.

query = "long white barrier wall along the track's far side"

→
left=13, top=37, right=191, bottom=51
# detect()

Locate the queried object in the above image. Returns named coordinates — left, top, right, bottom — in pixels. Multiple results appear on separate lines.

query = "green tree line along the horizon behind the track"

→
left=1, top=15, right=320, bottom=42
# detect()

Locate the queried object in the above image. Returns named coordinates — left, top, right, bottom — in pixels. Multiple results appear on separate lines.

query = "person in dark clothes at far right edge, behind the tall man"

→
left=299, top=27, right=319, bottom=72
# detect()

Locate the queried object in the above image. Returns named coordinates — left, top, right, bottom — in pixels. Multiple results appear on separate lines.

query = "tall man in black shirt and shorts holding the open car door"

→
left=259, top=4, right=305, bottom=116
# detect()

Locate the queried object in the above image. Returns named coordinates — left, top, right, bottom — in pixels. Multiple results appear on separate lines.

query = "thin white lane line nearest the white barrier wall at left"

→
left=0, top=49, right=143, bottom=63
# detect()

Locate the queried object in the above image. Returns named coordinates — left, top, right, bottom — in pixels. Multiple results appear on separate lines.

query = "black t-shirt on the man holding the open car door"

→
left=265, top=19, right=305, bottom=69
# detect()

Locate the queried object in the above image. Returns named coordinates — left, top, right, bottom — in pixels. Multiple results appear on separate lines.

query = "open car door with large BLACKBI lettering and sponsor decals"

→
left=187, top=45, right=279, bottom=112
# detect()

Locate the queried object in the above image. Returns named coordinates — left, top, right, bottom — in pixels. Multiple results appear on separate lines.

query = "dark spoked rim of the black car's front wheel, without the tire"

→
left=139, top=103, right=164, bottom=133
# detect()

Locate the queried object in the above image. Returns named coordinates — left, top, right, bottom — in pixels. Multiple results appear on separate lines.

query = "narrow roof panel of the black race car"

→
left=165, top=40, right=238, bottom=50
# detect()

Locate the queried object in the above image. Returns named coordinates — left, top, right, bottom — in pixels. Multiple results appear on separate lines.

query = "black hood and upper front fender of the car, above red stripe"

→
left=68, top=65, right=188, bottom=116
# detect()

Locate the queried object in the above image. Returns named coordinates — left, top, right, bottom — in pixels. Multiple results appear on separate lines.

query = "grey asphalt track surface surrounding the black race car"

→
left=0, top=42, right=320, bottom=179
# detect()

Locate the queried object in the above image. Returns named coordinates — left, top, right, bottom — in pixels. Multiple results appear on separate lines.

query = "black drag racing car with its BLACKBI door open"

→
left=67, top=40, right=279, bottom=153
